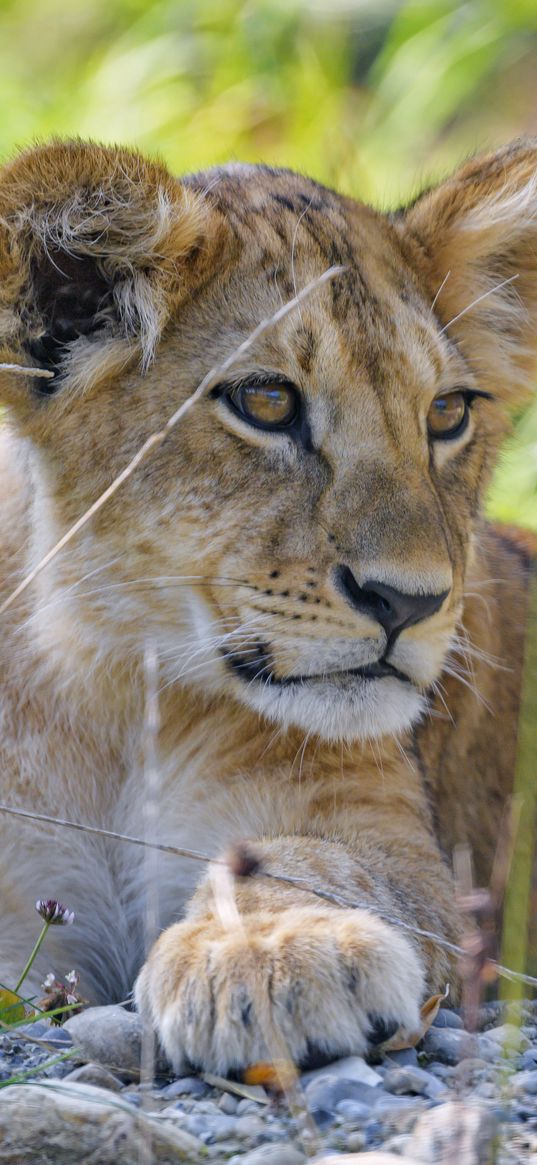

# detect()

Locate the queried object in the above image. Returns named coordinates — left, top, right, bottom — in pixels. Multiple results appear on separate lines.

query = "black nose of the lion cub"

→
left=337, top=566, right=450, bottom=638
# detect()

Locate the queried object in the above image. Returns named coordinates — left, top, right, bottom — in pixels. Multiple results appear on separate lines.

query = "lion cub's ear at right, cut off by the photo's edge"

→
left=397, top=140, right=537, bottom=402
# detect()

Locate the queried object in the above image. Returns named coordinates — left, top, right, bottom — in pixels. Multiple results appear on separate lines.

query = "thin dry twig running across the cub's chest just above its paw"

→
left=0, top=804, right=537, bottom=987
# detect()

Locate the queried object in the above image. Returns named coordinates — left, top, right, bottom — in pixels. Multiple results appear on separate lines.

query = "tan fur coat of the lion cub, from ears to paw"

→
left=0, top=142, right=537, bottom=1072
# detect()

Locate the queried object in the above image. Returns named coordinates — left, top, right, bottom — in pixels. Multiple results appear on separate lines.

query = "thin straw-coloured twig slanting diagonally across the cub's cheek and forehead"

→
left=0, top=267, right=345, bottom=615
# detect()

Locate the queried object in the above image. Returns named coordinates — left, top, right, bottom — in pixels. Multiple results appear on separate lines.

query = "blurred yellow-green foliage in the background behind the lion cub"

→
left=0, top=0, right=537, bottom=530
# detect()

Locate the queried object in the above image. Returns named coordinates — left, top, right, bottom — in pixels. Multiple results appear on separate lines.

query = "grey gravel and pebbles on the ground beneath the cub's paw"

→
left=0, top=1002, right=537, bottom=1165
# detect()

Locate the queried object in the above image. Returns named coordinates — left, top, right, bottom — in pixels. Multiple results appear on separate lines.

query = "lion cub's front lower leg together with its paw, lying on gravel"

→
left=135, top=833, right=454, bottom=1073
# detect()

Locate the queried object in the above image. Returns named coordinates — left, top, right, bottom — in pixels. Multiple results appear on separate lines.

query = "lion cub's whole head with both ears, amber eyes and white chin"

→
left=0, top=142, right=537, bottom=739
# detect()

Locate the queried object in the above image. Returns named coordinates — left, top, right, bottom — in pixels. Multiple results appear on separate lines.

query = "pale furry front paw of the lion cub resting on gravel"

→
left=135, top=906, right=424, bottom=1074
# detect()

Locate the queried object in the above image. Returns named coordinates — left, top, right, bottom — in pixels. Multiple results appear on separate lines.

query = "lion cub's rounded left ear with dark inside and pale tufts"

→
left=0, top=142, right=214, bottom=404
